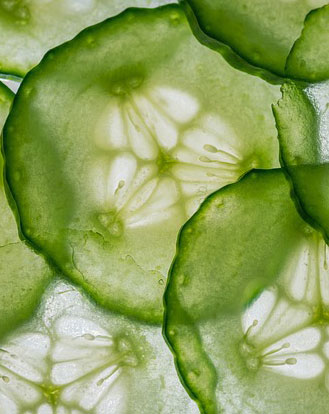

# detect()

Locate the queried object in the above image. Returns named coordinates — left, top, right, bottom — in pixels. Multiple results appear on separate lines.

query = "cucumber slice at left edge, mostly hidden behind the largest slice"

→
left=0, top=83, right=52, bottom=338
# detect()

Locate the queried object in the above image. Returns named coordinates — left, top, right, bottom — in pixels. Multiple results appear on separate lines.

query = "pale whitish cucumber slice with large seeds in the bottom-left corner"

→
left=0, top=274, right=198, bottom=414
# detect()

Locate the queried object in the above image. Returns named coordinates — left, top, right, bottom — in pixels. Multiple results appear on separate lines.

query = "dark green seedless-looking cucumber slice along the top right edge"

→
left=182, top=0, right=327, bottom=76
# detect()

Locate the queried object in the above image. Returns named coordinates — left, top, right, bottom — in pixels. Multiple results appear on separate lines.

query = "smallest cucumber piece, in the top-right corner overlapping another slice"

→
left=286, top=5, right=329, bottom=82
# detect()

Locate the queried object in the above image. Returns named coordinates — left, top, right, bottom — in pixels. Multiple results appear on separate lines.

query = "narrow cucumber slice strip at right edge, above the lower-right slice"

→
left=274, top=82, right=329, bottom=241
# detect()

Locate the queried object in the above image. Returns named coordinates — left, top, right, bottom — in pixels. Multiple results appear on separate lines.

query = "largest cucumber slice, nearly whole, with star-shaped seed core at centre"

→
left=4, top=5, right=278, bottom=322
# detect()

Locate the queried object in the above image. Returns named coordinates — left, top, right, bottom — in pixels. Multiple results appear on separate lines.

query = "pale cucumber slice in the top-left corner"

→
left=0, top=0, right=176, bottom=76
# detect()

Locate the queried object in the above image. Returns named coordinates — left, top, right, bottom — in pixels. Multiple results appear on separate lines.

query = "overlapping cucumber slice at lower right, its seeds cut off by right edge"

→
left=164, top=170, right=329, bottom=414
